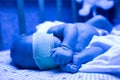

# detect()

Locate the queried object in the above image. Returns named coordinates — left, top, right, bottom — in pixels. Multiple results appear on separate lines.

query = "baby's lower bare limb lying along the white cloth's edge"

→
left=74, top=42, right=111, bottom=64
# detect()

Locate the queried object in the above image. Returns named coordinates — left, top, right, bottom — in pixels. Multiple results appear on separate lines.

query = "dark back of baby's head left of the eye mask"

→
left=10, top=34, right=36, bottom=68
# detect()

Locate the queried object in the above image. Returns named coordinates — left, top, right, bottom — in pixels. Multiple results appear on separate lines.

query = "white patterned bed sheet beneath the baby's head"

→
left=0, top=50, right=120, bottom=80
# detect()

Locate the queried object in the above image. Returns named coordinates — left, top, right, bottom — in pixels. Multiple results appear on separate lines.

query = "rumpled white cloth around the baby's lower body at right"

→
left=80, top=29, right=120, bottom=74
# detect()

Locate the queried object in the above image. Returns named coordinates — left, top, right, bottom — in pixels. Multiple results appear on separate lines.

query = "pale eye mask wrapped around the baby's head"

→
left=33, top=32, right=57, bottom=69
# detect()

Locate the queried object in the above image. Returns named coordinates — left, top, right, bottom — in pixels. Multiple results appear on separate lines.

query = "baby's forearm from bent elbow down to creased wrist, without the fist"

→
left=61, top=24, right=78, bottom=50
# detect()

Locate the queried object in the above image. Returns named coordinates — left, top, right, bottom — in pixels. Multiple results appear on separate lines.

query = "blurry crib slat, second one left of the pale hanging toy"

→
left=56, top=0, right=62, bottom=20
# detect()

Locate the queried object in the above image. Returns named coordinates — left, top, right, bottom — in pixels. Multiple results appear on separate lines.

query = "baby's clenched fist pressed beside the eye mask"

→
left=51, top=47, right=73, bottom=65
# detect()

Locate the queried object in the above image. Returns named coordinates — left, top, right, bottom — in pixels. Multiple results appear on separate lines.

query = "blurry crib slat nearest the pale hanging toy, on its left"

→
left=71, top=0, right=77, bottom=22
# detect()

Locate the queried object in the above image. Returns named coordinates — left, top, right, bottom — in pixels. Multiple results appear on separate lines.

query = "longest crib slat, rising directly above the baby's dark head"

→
left=17, top=0, right=26, bottom=34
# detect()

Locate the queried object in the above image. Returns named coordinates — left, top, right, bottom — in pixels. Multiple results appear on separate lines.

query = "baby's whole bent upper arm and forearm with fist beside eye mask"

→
left=48, top=24, right=78, bottom=65
